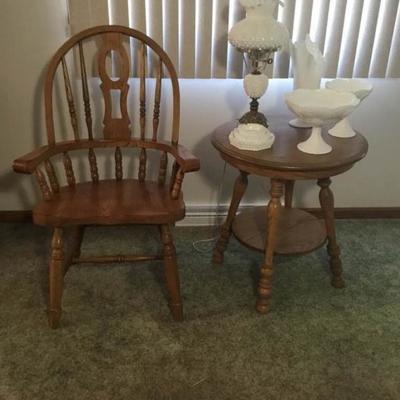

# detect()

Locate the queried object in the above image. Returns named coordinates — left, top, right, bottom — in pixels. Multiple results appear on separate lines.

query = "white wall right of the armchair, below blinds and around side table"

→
left=181, top=79, right=400, bottom=214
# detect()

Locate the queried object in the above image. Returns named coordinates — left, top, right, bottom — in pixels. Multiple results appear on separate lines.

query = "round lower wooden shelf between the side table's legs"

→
left=232, top=207, right=327, bottom=255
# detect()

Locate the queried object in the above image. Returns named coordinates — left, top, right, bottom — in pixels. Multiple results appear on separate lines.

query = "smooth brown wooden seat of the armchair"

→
left=33, top=179, right=185, bottom=226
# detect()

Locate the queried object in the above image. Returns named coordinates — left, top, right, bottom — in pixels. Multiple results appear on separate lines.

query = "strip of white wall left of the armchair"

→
left=0, top=0, right=67, bottom=210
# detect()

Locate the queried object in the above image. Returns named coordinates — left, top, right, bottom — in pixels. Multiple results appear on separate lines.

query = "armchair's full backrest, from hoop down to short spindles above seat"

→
left=36, top=25, right=180, bottom=191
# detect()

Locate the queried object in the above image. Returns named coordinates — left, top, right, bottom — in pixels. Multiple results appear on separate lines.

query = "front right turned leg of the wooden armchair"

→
left=160, top=225, right=183, bottom=321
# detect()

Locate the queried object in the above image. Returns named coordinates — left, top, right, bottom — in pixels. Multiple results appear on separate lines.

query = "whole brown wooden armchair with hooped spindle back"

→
left=13, top=25, right=200, bottom=328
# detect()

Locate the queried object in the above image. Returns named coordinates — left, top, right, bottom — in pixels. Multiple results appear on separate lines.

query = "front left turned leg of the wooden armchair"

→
left=48, top=228, right=64, bottom=329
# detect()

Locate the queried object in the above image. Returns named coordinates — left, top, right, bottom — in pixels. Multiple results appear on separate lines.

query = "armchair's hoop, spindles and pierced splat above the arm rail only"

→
left=44, top=25, right=180, bottom=145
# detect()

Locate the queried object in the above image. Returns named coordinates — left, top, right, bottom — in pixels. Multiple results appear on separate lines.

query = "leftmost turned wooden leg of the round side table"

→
left=212, top=171, right=248, bottom=264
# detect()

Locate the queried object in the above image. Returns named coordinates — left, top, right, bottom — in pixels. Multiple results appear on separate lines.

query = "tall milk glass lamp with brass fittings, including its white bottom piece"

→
left=228, top=0, right=289, bottom=150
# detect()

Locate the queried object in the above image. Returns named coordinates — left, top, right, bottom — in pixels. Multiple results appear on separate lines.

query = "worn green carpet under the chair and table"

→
left=0, top=220, right=400, bottom=400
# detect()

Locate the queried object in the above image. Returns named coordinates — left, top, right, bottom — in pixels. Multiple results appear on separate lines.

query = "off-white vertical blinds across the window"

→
left=67, top=0, right=400, bottom=78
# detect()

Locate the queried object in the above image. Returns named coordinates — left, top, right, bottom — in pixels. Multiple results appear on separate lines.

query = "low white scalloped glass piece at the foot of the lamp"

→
left=229, top=124, right=275, bottom=151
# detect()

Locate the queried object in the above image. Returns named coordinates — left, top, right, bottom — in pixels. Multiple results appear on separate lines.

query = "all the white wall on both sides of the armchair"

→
left=0, top=0, right=400, bottom=219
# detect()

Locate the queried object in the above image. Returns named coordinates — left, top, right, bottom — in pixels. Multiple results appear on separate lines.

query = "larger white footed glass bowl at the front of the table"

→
left=285, top=89, right=360, bottom=154
